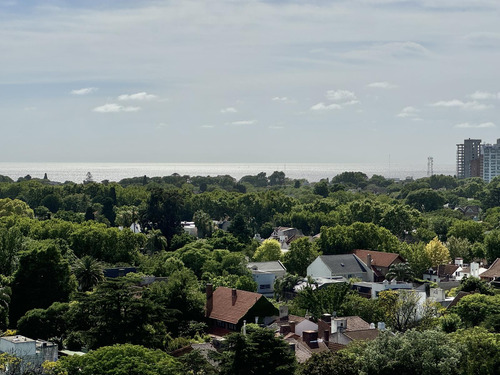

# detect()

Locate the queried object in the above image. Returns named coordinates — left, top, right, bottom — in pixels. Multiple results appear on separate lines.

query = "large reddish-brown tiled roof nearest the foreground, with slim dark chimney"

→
left=208, top=286, right=270, bottom=324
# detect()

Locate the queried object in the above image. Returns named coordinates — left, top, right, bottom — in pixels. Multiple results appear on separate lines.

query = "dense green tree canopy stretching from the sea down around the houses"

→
left=0, top=172, right=500, bottom=374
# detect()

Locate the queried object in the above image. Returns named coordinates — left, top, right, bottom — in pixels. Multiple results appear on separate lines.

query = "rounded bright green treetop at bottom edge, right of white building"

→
left=53, top=344, right=184, bottom=375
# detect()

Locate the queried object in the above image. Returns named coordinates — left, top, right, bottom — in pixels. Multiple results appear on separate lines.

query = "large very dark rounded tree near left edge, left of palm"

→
left=10, top=240, right=76, bottom=322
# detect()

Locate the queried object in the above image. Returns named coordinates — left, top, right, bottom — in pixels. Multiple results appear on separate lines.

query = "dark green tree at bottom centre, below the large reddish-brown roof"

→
left=220, top=327, right=297, bottom=375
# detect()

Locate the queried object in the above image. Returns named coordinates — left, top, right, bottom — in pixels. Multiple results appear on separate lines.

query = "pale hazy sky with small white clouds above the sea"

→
left=0, top=0, right=500, bottom=168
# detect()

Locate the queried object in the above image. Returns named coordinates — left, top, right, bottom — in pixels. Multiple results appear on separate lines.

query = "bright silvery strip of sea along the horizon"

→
left=0, top=162, right=455, bottom=183
